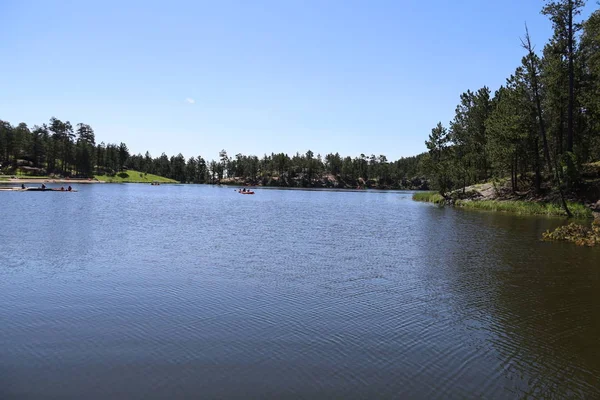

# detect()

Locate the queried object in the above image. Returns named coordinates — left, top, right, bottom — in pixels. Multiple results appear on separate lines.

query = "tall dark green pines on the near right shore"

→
left=423, top=0, right=600, bottom=203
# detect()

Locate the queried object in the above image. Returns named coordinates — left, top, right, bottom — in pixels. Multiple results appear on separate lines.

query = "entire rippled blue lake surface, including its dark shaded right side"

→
left=0, top=184, right=600, bottom=400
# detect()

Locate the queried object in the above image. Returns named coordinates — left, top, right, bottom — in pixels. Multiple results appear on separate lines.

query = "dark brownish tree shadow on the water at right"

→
left=422, top=208, right=600, bottom=398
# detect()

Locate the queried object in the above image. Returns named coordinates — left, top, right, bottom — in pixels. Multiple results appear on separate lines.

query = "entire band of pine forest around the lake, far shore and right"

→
left=0, top=0, right=600, bottom=195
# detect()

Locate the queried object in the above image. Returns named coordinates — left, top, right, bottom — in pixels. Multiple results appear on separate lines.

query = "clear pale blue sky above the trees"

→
left=0, top=0, right=597, bottom=159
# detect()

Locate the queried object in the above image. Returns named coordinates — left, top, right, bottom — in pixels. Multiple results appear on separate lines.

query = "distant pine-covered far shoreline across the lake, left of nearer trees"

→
left=0, top=117, right=428, bottom=189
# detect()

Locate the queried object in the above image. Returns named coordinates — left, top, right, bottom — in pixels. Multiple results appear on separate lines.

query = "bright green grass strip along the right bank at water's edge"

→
left=413, top=192, right=592, bottom=218
